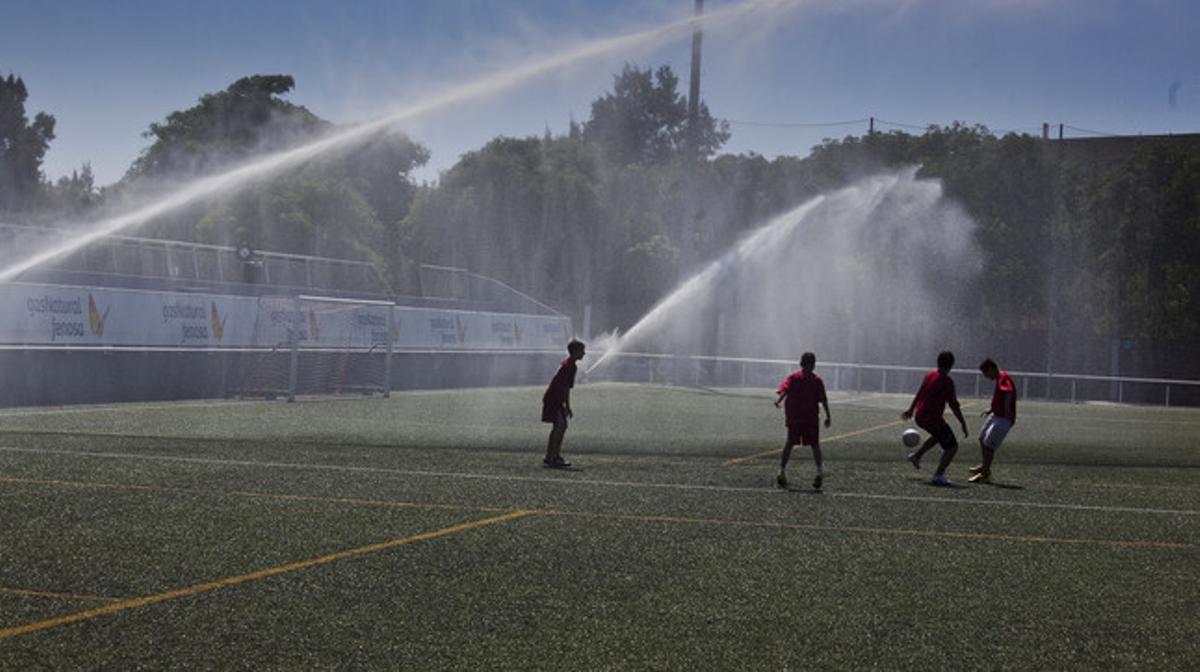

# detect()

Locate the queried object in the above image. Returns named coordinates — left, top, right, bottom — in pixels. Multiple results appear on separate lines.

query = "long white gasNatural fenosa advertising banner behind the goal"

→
left=0, top=283, right=571, bottom=349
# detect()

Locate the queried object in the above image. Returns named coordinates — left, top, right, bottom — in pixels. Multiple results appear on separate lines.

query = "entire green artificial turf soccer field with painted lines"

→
left=0, top=384, right=1200, bottom=670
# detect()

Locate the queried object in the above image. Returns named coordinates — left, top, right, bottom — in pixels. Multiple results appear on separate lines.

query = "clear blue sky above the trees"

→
left=0, top=0, right=1200, bottom=185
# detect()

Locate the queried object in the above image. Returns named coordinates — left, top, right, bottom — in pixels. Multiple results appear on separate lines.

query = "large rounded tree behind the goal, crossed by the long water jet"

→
left=121, top=76, right=428, bottom=276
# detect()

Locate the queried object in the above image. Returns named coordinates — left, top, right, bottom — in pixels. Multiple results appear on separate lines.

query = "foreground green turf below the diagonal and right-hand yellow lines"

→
left=6, top=517, right=1192, bottom=670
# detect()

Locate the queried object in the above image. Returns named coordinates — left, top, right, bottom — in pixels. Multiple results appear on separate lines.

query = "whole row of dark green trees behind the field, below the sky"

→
left=0, top=65, right=1200, bottom=355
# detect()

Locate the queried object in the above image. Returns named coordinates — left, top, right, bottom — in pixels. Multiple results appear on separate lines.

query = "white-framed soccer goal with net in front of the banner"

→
left=225, top=295, right=395, bottom=401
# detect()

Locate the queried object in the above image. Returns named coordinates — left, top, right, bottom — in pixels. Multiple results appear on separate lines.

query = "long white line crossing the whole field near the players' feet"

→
left=0, top=446, right=1200, bottom=516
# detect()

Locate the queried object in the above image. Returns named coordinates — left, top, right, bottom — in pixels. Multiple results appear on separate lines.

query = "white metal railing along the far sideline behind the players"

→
left=588, top=352, right=1200, bottom=406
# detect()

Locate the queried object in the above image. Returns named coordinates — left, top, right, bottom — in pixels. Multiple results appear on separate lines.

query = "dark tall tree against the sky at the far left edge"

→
left=0, top=73, right=54, bottom=212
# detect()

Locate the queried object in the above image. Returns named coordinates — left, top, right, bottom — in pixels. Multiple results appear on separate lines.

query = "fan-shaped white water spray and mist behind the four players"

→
left=588, top=168, right=982, bottom=371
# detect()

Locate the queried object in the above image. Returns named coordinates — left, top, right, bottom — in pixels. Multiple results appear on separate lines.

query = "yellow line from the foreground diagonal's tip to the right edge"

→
left=547, top=509, right=1200, bottom=550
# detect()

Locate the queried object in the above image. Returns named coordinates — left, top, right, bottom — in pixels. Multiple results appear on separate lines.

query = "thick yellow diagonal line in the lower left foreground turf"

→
left=0, top=511, right=533, bottom=640
